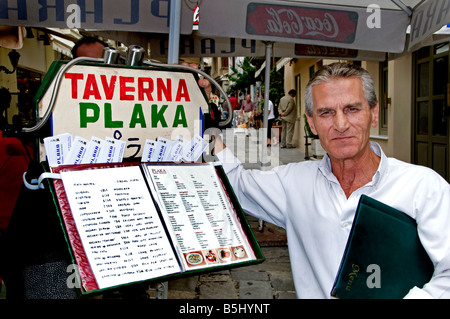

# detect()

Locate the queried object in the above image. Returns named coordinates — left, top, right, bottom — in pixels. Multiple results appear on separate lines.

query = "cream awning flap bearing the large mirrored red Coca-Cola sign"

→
left=199, top=0, right=444, bottom=53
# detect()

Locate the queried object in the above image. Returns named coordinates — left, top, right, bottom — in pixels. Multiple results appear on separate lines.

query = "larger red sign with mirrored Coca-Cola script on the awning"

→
left=246, top=2, right=358, bottom=43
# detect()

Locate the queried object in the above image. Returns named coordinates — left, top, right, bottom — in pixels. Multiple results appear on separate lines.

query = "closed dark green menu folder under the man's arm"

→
left=331, top=195, right=434, bottom=299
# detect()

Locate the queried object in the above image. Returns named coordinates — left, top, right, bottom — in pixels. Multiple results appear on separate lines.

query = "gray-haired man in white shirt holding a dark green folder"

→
left=215, top=63, right=450, bottom=298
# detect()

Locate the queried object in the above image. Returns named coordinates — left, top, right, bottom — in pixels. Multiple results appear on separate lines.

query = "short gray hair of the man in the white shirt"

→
left=305, top=62, right=378, bottom=116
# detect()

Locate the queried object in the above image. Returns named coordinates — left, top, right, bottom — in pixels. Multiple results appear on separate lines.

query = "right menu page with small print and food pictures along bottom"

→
left=144, top=164, right=255, bottom=270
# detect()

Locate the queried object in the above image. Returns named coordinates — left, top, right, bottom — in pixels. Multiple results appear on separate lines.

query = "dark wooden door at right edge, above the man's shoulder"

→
left=412, top=42, right=450, bottom=180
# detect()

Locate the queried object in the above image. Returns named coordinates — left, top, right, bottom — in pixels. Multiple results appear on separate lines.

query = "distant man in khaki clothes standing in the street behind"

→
left=278, top=90, right=297, bottom=148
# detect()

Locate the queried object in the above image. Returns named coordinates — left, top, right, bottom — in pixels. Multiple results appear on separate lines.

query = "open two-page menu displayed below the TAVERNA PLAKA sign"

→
left=49, top=163, right=262, bottom=293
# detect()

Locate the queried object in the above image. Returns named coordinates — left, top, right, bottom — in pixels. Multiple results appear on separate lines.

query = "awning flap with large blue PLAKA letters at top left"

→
left=0, top=0, right=194, bottom=34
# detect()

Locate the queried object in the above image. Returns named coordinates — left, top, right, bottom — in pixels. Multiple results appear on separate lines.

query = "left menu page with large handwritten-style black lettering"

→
left=61, top=166, right=181, bottom=289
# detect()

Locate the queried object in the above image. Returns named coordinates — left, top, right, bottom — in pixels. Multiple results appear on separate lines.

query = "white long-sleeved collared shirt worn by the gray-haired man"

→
left=217, top=143, right=450, bottom=298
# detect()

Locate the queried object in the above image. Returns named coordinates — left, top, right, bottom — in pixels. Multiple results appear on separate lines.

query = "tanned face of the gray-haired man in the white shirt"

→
left=307, top=78, right=378, bottom=160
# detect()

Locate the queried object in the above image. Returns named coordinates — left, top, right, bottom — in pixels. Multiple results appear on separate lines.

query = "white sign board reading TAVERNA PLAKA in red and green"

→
left=39, top=65, right=208, bottom=158
